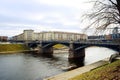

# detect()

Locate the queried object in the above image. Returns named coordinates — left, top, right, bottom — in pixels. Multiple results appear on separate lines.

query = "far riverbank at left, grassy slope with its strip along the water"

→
left=0, top=44, right=31, bottom=54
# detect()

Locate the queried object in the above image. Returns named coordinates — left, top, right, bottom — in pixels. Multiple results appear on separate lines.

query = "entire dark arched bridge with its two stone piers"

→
left=28, top=40, right=120, bottom=65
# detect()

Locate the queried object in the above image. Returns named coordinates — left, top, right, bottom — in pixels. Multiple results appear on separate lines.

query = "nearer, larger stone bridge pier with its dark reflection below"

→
left=68, top=43, right=85, bottom=67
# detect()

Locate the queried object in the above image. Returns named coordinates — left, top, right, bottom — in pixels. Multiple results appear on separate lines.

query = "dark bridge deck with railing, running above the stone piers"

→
left=28, top=40, right=120, bottom=49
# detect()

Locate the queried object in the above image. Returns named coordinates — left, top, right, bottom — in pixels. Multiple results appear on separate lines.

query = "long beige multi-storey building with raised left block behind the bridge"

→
left=12, top=30, right=87, bottom=40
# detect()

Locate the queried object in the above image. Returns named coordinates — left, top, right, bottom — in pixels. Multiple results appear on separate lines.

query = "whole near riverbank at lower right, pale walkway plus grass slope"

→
left=44, top=60, right=120, bottom=80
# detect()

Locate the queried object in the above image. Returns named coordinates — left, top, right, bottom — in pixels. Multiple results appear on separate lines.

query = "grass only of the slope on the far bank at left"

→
left=0, top=44, right=29, bottom=53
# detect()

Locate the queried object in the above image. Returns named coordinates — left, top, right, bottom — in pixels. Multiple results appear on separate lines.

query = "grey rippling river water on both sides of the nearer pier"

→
left=0, top=47, right=116, bottom=80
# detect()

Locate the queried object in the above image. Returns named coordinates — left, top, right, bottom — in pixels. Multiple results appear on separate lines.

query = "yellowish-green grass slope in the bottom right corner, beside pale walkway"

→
left=70, top=60, right=120, bottom=80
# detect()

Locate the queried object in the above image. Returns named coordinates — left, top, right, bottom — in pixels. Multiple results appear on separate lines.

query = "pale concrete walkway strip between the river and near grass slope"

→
left=44, top=60, right=107, bottom=80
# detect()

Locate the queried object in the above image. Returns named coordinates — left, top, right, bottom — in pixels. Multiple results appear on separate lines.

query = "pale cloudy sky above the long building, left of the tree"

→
left=0, top=0, right=92, bottom=37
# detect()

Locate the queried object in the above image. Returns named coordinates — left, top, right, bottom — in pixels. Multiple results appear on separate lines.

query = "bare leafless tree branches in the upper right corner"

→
left=85, top=0, right=120, bottom=32
